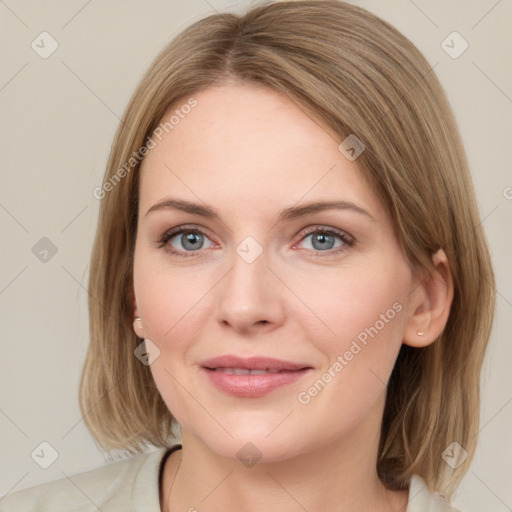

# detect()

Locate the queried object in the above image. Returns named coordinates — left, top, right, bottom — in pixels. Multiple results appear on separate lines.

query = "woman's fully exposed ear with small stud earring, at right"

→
left=403, top=249, right=454, bottom=347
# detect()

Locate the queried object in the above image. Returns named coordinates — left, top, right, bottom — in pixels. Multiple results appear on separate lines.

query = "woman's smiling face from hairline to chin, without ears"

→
left=134, top=85, right=417, bottom=461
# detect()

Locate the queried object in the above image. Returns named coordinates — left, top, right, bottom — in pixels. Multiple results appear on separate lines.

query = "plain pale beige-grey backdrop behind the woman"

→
left=0, top=0, right=512, bottom=512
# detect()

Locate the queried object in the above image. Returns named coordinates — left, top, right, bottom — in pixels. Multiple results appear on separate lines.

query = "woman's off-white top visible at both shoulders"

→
left=0, top=445, right=457, bottom=512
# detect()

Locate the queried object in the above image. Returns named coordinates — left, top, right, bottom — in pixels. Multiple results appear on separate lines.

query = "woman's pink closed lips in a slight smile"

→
left=200, top=355, right=312, bottom=398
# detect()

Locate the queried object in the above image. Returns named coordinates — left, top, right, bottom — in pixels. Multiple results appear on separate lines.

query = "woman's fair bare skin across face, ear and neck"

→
left=134, top=84, right=453, bottom=512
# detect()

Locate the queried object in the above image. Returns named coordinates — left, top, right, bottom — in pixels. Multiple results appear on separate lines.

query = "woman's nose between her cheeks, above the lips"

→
left=216, top=242, right=285, bottom=334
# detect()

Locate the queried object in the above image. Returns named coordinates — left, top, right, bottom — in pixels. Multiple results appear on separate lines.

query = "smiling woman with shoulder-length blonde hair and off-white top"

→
left=1, top=0, right=494, bottom=512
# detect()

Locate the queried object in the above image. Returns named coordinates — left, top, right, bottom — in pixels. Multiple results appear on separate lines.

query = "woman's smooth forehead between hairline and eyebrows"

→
left=139, top=84, right=381, bottom=219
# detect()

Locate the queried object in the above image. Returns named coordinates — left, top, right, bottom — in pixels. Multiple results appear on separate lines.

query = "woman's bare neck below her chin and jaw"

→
left=162, top=406, right=408, bottom=512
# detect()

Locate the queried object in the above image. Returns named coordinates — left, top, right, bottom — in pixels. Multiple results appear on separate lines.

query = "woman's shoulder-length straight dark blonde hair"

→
left=80, top=0, right=495, bottom=496
